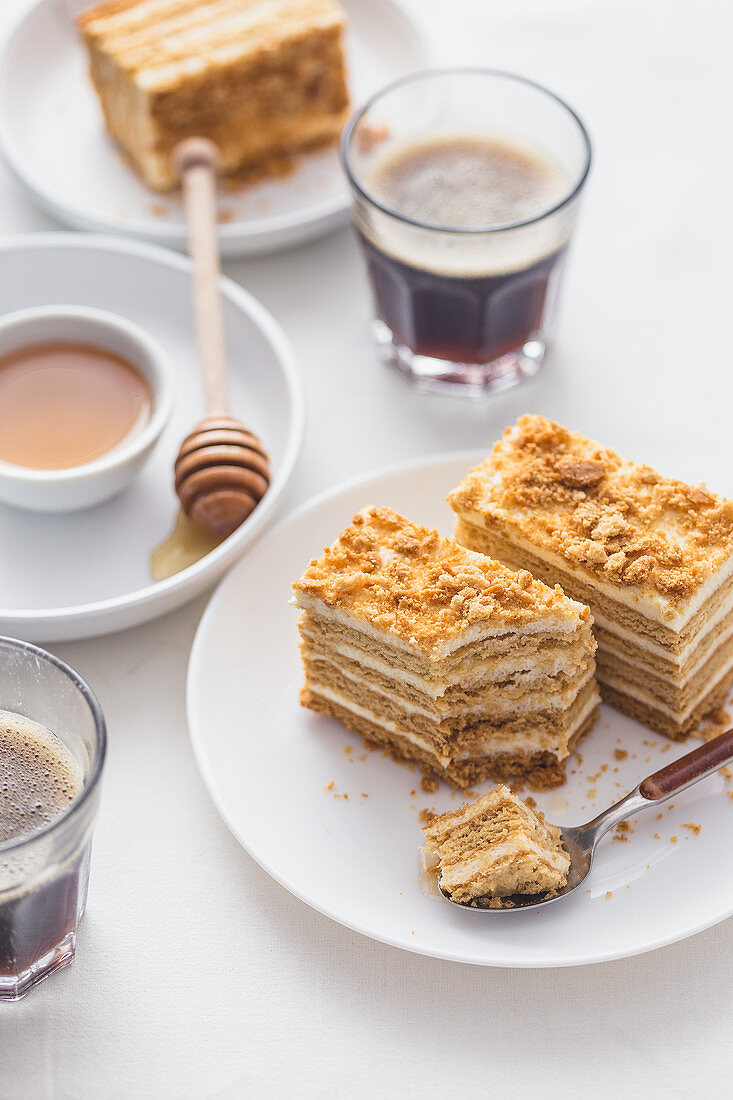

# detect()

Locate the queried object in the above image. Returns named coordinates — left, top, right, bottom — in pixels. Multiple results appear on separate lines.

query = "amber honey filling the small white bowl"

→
left=0, top=343, right=153, bottom=470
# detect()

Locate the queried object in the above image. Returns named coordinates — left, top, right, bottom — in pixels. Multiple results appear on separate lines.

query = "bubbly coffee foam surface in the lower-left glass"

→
left=0, top=711, right=84, bottom=844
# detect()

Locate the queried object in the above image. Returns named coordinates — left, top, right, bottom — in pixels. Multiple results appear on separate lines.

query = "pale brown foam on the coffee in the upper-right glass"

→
left=354, top=134, right=576, bottom=278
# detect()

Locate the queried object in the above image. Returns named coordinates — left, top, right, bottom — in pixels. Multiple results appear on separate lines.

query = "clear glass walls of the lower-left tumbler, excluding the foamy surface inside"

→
left=0, top=638, right=107, bottom=1000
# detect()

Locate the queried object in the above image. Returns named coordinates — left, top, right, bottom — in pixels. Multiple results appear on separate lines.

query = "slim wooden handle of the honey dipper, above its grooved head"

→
left=174, top=138, right=229, bottom=415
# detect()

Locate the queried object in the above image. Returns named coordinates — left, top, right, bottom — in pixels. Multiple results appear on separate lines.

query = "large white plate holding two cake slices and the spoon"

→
left=188, top=454, right=733, bottom=967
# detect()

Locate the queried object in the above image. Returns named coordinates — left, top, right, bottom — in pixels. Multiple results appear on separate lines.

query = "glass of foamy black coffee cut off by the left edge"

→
left=0, top=638, right=107, bottom=1000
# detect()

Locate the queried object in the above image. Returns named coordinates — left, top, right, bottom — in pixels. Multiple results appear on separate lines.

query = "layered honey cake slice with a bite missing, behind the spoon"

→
left=294, top=508, right=599, bottom=787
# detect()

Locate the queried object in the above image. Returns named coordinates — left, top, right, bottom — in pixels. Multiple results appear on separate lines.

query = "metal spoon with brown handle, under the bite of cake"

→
left=438, top=729, right=733, bottom=914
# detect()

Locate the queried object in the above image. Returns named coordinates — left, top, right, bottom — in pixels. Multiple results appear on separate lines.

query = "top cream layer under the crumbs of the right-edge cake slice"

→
left=458, top=510, right=733, bottom=633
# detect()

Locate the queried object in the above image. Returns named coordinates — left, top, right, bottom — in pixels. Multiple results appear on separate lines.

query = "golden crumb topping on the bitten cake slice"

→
left=293, top=507, right=591, bottom=653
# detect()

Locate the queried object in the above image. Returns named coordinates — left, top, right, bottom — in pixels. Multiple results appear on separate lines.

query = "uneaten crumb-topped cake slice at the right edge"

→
left=449, top=416, right=733, bottom=739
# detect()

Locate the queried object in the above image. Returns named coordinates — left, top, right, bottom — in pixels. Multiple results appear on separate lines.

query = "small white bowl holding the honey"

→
left=0, top=306, right=173, bottom=512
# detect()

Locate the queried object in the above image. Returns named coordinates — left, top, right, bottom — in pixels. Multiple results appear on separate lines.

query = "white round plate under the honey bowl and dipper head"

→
left=0, top=233, right=304, bottom=641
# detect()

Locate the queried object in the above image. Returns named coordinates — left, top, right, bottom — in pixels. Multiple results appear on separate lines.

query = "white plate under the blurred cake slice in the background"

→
left=0, top=0, right=428, bottom=256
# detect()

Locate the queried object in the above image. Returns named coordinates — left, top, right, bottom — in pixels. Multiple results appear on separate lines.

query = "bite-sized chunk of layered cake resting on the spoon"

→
left=423, top=784, right=570, bottom=902
